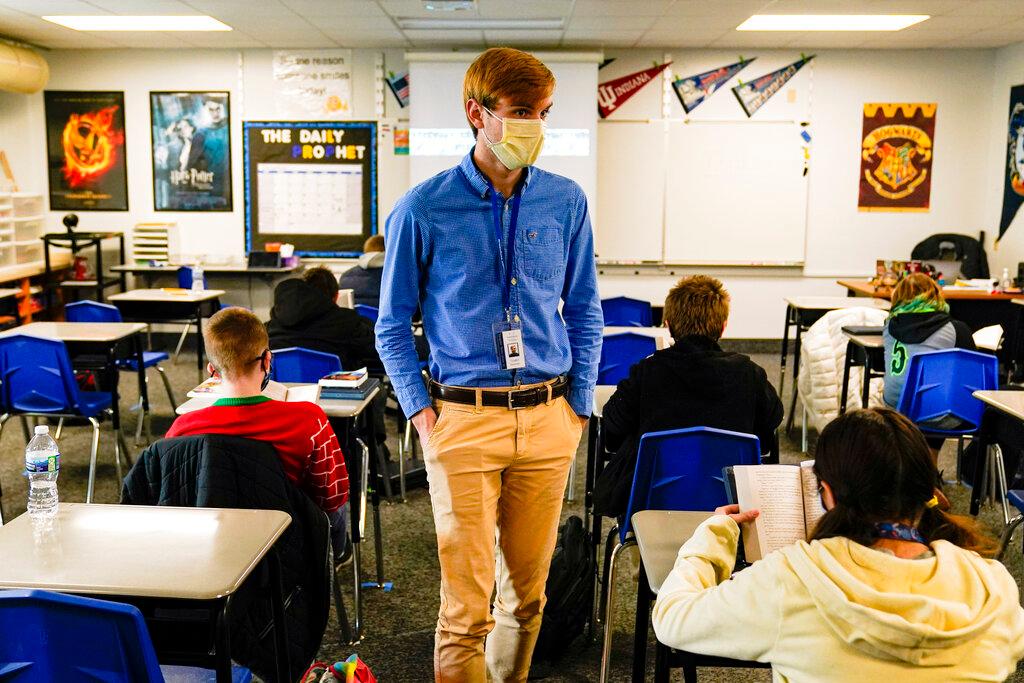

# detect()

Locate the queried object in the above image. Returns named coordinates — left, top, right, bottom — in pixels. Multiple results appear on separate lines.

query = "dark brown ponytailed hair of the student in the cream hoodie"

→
left=812, top=408, right=997, bottom=556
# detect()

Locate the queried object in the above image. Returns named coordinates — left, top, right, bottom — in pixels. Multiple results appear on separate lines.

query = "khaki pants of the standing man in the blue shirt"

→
left=424, top=389, right=583, bottom=683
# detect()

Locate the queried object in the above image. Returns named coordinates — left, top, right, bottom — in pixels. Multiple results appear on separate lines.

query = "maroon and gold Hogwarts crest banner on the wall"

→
left=857, top=102, right=938, bottom=211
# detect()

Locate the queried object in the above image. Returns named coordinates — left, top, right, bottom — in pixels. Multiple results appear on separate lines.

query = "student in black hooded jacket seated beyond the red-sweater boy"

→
left=266, top=266, right=381, bottom=370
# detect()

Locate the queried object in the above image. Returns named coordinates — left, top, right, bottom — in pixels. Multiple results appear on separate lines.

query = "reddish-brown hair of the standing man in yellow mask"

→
left=462, top=47, right=555, bottom=137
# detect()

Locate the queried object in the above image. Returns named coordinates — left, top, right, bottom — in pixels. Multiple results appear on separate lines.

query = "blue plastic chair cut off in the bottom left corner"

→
left=0, top=590, right=252, bottom=683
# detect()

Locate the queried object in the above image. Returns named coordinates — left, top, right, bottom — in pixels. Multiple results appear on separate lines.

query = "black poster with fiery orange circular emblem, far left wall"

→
left=44, top=90, right=128, bottom=211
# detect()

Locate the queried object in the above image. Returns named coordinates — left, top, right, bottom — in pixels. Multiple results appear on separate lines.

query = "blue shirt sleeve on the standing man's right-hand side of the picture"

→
left=562, top=187, right=604, bottom=417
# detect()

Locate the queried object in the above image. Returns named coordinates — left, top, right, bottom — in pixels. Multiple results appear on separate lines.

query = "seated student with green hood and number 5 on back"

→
left=882, top=272, right=975, bottom=409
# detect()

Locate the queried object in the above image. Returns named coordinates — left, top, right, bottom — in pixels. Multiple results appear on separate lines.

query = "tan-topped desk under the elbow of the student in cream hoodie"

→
left=633, top=510, right=771, bottom=683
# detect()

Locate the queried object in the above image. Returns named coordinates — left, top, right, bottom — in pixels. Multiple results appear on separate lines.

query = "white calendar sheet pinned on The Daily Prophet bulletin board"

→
left=256, top=164, right=362, bottom=234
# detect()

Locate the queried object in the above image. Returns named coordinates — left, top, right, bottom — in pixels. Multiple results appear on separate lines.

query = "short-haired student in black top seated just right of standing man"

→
left=594, top=275, right=782, bottom=516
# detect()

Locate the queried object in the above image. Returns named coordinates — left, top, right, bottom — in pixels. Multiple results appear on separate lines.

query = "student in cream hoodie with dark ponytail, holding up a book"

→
left=653, top=409, right=1024, bottom=683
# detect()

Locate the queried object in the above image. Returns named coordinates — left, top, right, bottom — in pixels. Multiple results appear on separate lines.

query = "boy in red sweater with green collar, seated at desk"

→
left=166, top=307, right=351, bottom=561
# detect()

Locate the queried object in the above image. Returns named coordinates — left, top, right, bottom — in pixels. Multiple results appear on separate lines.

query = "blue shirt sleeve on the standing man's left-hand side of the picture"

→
left=377, top=195, right=430, bottom=418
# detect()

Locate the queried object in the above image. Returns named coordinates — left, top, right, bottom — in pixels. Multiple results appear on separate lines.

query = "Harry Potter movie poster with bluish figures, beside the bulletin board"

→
left=150, top=92, right=231, bottom=211
